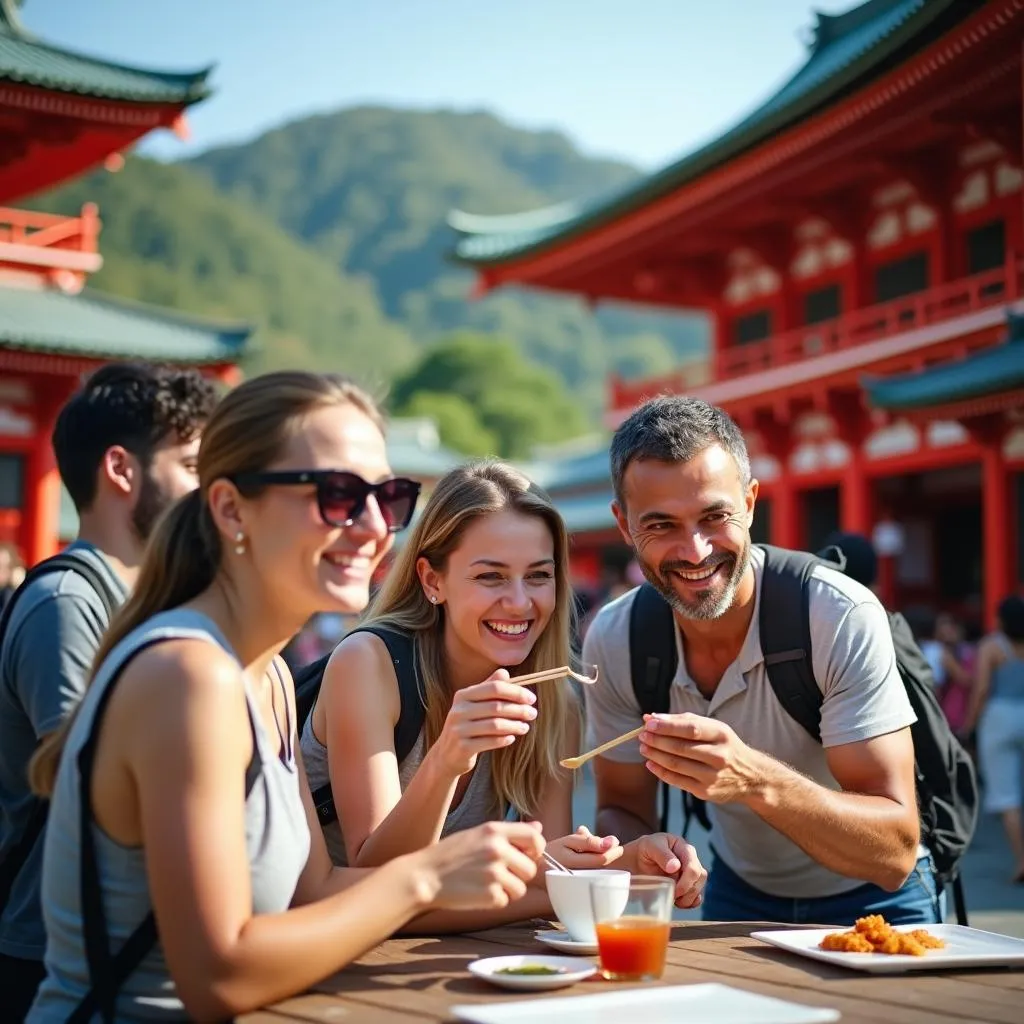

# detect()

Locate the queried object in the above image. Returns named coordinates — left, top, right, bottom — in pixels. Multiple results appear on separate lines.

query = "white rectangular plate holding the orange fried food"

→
left=751, top=925, right=1024, bottom=974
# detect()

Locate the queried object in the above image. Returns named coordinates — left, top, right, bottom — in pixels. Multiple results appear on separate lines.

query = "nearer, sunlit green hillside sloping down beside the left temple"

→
left=30, top=158, right=417, bottom=386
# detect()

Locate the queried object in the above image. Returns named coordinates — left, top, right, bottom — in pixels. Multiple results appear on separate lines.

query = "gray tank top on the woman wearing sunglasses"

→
left=28, top=608, right=309, bottom=1024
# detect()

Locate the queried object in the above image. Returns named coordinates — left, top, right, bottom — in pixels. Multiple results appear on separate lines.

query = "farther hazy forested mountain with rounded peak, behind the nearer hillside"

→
left=193, top=106, right=706, bottom=410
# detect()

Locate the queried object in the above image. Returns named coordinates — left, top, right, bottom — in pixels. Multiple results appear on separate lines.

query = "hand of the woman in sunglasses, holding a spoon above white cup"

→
left=407, top=821, right=544, bottom=910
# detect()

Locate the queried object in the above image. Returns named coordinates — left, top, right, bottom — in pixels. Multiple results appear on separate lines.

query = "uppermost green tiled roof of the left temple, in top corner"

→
left=0, top=0, right=212, bottom=104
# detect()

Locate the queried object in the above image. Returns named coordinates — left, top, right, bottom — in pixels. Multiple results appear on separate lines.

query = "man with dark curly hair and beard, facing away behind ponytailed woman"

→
left=0, top=362, right=217, bottom=1021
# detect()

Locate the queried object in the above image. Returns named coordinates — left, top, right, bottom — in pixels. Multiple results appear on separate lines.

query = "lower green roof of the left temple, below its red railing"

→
left=0, top=288, right=252, bottom=364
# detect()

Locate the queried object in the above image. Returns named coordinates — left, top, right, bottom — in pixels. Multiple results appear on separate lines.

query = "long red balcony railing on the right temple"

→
left=608, top=255, right=1024, bottom=410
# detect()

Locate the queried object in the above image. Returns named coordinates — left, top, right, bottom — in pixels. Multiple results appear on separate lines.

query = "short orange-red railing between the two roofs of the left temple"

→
left=0, top=203, right=102, bottom=291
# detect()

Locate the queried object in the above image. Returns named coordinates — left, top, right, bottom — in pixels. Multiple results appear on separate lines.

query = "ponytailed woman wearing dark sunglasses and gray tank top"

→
left=29, top=373, right=543, bottom=1024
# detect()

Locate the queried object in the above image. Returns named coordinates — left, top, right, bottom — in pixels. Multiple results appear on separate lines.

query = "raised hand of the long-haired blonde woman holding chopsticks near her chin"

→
left=431, top=669, right=537, bottom=776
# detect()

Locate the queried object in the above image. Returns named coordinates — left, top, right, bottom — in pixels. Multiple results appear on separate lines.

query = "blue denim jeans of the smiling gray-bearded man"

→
left=701, top=850, right=945, bottom=928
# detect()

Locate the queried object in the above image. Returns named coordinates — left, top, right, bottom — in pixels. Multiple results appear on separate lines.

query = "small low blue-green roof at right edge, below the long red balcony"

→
left=864, top=316, right=1024, bottom=411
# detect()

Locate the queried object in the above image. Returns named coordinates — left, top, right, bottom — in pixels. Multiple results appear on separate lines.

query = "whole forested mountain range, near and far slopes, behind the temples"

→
left=29, top=106, right=706, bottom=430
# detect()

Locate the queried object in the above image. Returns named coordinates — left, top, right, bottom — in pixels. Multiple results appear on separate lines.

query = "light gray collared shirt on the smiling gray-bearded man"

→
left=583, top=548, right=915, bottom=898
